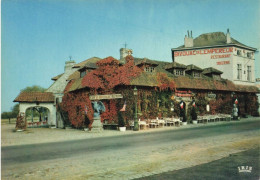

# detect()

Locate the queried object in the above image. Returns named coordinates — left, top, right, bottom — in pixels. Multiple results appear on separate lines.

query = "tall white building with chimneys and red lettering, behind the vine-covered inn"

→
left=172, top=30, right=256, bottom=85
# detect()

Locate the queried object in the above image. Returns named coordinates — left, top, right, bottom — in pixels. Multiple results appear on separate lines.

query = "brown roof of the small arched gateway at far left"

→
left=14, top=92, right=54, bottom=102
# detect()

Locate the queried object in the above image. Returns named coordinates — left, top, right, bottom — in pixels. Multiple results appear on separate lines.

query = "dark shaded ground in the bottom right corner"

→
left=139, top=147, right=260, bottom=180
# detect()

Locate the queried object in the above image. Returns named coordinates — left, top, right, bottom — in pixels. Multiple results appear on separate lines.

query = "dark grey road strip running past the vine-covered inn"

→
left=1, top=121, right=260, bottom=168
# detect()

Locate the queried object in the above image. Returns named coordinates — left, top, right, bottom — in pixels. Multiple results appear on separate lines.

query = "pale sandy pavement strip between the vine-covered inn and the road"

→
left=1, top=117, right=260, bottom=146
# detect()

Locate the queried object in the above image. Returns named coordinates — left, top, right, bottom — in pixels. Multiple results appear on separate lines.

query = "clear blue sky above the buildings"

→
left=1, top=0, right=260, bottom=112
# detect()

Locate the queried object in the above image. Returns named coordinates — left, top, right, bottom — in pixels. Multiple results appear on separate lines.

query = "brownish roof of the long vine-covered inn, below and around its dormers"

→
left=64, top=55, right=258, bottom=92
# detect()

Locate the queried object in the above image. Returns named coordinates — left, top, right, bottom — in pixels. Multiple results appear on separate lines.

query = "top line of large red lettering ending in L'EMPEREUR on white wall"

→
left=174, top=47, right=233, bottom=57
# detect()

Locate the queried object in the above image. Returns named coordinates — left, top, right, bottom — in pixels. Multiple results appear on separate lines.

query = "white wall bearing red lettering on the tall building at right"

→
left=174, top=47, right=255, bottom=85
